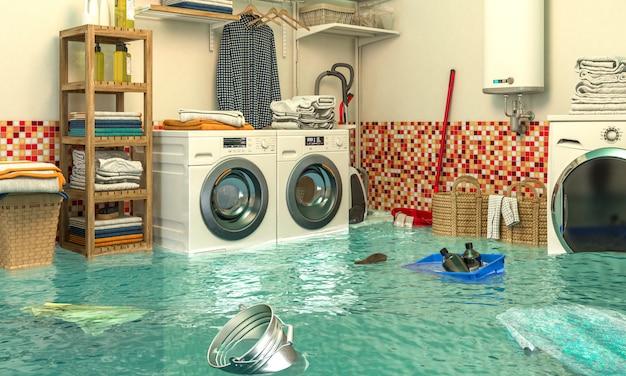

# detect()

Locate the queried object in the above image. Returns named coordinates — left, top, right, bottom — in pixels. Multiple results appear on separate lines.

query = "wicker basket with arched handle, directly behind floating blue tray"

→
left=432, top=175, right=489, bottom=237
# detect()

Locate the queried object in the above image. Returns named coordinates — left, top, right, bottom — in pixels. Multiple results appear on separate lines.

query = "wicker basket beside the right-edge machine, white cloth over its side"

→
left=500, top=179, right=548, bottom=245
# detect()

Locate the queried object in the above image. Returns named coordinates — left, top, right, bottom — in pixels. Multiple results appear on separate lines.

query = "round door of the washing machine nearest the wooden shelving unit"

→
left=200, top=158, right=269, bottom=240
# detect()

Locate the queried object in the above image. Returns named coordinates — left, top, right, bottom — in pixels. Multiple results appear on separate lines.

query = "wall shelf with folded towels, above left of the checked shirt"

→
left=135, top=4, right=239, bottom=24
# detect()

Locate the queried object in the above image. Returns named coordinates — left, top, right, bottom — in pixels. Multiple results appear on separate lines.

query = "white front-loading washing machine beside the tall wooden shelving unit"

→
left=153, top=130, right=276, bottom=254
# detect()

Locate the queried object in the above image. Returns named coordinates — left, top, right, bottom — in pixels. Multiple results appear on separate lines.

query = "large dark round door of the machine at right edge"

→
left=550, top=148, right=626, bottom=252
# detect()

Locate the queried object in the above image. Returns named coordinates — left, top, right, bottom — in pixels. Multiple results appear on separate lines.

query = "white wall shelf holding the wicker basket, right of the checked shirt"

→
left=296, top=23, right=400, bottom=46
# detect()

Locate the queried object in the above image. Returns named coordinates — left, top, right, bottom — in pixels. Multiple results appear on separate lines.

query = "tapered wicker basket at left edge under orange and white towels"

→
left=0, top=193, right=63, bottom=269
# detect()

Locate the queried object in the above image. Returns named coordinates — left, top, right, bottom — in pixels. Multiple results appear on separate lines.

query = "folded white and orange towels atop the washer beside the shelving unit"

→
left=163, top=109, right=254, bottom=131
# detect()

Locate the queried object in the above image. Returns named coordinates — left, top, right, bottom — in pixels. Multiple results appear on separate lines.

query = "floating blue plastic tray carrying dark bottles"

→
left=402, top=253, right=504, bottom=281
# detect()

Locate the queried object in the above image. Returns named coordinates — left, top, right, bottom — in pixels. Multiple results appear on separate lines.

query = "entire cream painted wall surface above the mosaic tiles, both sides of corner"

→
left=0, top=0, right=626, bottom=121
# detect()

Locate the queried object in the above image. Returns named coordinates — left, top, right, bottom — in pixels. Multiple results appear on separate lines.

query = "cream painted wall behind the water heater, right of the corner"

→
left=361, top=0, right=626, bottom=121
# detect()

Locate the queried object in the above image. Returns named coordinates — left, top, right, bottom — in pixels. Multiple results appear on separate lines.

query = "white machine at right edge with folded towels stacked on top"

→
left=548, top=115, right=626, bottom=254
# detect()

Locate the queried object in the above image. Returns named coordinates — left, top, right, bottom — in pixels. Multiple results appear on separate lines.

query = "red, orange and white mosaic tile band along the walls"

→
left=0, top=120, right=548, bottom=210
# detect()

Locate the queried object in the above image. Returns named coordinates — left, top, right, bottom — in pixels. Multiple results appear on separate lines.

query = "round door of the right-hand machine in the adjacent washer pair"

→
left=286, top=155, right=343, bottom=230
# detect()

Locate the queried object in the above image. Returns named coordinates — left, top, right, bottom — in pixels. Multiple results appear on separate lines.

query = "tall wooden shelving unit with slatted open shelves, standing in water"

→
left=59, top=25, right=152, bottom=258
